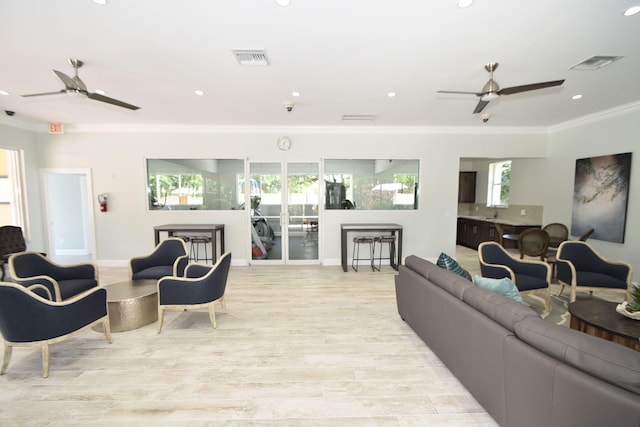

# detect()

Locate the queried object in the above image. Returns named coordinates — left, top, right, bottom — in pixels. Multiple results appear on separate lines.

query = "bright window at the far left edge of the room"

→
left=0, top=149, right=28, bottom=234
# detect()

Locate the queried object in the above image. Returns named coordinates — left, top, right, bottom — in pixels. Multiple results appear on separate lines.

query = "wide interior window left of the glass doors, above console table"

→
left=147, top=159, right=244, bottom=210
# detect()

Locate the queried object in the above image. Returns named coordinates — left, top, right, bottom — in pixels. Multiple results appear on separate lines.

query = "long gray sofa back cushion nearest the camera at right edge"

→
left=514, top=318, right=640, bottom=394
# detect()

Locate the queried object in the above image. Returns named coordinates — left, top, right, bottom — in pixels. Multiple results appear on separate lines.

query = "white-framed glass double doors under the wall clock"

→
left=249, top=162, right=319, bottom=264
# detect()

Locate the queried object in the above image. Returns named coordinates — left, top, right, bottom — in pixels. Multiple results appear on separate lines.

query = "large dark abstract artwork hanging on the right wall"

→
left=571, top=153, right=631, bottom=243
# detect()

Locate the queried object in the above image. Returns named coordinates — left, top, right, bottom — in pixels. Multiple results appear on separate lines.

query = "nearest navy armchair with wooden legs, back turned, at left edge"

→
left=0, top=282, right=111, bottom=378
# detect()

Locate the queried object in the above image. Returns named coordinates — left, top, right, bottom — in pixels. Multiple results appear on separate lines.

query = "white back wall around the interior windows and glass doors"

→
left=32, top=129, right=546, bottom=264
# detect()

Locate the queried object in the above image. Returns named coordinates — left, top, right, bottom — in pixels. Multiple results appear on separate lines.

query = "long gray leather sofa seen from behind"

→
left=395, top=256, right=640, bottom=427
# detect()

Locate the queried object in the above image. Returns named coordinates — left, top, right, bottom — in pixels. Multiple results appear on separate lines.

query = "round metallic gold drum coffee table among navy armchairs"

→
left=94, top=279, right=158, bottom=332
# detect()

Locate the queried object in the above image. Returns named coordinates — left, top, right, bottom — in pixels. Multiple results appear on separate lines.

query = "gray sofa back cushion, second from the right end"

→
left=462, top=286, right=540, bottom=332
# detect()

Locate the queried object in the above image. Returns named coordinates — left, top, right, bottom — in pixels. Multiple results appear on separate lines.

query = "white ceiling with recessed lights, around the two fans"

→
left=0, top=0, right=640, bottom=128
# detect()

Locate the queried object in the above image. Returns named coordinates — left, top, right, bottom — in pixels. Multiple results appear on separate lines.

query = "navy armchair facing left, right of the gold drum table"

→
left=158, top=252, right=231, bottom=333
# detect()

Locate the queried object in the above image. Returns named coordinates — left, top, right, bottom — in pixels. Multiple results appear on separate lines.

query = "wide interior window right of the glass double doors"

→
left=324, top=159, right=419, bottom=210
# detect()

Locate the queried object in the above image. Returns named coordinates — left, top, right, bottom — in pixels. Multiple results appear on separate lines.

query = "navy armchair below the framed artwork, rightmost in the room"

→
left=556, top=240, right=633, bottom=301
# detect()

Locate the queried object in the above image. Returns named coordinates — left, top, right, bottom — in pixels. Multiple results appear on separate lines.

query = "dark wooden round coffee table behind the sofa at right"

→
left=569, top=298, right=640, bottom=351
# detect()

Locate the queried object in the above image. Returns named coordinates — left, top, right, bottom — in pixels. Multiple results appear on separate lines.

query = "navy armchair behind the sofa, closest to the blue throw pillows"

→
left=478, top=242, right=551, bottom=313
